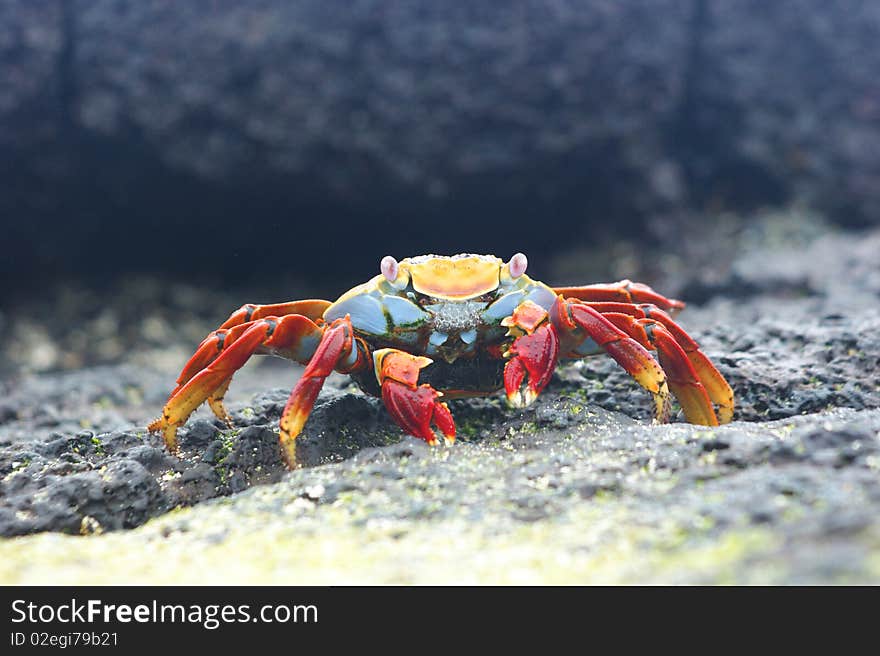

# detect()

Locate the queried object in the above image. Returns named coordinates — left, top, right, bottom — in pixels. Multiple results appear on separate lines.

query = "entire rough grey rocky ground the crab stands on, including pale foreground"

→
left=0, top=222, right=880, bottom=583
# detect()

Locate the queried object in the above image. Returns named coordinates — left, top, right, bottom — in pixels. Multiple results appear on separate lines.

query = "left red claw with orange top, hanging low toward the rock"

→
left=373, top=349, right=455, bottom=445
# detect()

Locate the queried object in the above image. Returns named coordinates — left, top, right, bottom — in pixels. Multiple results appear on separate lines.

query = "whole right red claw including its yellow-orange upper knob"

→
left=501, top=301, right=559, bottom=408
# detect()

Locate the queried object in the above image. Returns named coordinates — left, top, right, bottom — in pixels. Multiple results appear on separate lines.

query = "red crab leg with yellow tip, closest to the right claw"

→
left=550, top=297, right=670, bottom=422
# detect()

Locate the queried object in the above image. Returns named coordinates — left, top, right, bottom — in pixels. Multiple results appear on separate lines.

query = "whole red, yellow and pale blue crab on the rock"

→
left=148, top=253, right=734, bottom=469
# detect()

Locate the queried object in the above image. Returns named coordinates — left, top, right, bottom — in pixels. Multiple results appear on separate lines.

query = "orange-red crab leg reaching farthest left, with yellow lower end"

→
left=147, top=314, right=321, bottom=453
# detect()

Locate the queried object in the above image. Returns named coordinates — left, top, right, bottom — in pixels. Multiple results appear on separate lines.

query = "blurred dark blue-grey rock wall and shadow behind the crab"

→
left=0, top=0, right=880, bottom=372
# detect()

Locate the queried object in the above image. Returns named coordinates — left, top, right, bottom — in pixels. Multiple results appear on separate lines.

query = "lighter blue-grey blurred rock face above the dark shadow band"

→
left=6, top=0, right=880, bottom=221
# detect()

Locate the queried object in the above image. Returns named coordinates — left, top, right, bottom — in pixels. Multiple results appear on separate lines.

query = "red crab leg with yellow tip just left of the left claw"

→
left=278, top=315, right=365, bottom=469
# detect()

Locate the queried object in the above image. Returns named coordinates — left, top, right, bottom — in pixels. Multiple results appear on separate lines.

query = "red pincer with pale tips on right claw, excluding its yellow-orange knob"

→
left=504, top=324, right=559, bottom=408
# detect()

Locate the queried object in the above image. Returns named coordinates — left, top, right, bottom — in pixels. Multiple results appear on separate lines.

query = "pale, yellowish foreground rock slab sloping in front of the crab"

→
left=0, top=402, right=880, bottom=584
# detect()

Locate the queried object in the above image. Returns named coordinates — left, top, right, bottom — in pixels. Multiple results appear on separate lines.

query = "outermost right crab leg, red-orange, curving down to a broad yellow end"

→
left=588, top=303, right=734, bottom=424
